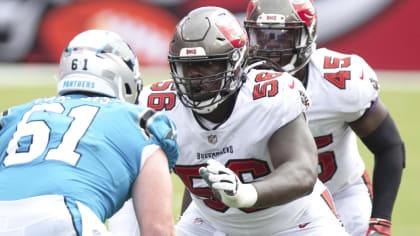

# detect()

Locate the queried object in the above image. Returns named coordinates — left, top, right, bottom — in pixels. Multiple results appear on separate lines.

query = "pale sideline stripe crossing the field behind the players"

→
left=0, top=63, right=420, bottom=92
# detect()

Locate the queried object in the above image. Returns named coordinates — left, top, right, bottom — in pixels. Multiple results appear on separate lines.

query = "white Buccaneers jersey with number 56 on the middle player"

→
left=139, top=70, right=325, bottom=235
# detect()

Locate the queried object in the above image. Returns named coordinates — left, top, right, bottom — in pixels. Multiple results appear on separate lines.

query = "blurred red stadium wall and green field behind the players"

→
left=0, top=0, right=420, bottom=236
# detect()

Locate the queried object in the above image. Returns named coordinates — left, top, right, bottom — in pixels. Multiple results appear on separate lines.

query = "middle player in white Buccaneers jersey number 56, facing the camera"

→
left=110, top=7, right=347, bottom=236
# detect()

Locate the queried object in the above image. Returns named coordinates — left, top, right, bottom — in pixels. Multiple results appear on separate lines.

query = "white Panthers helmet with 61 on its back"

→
left=57, top=30, right=142, bottom=103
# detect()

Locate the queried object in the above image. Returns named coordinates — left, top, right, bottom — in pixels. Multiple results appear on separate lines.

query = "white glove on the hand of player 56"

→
left=199, top=159, right=258, bottom=208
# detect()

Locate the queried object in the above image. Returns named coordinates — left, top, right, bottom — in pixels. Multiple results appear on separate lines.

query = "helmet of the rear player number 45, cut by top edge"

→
left=244, top=0, right=318, bottom=74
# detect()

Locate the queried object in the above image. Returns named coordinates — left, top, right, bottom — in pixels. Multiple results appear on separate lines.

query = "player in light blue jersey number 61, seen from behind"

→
left=0, top=30, right=179, bottom=236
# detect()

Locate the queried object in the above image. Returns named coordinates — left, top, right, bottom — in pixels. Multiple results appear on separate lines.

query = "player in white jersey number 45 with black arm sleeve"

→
left=244, top=0, right=405, bottom=236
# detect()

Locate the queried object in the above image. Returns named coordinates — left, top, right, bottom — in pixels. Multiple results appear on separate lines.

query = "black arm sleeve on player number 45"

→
left=362, top=115, right=405, bottom=220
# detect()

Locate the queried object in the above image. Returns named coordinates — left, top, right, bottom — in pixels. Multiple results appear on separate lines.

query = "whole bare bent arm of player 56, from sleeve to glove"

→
left=253, top=113, right=318, bottom=208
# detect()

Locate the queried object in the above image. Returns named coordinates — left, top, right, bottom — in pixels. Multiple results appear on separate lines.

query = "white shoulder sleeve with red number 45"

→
left=308, top=48, right=379, bottom=122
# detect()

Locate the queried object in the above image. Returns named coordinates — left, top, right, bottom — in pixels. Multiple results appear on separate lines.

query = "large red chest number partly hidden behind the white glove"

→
left=174, top=159, right=270, bottom=213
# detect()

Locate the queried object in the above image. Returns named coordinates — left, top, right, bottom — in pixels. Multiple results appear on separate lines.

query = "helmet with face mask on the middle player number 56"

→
left=168, top=7, right=248, bottom=114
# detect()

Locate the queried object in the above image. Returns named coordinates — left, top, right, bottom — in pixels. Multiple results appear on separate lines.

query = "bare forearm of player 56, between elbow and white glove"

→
left=252, top=160, right=317, bottom=208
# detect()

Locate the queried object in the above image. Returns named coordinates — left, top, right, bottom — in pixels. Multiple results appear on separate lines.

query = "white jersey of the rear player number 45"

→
left=306, top=48, right=379, bottom=194
